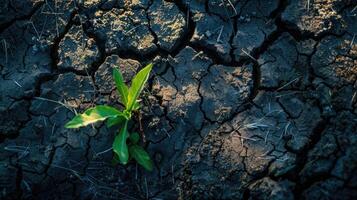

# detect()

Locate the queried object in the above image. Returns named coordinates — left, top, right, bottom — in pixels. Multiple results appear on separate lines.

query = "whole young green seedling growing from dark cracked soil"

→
left=65, top=64, right=153, bottom=171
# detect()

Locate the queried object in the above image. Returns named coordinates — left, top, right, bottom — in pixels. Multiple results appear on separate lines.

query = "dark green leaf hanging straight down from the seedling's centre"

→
left=113, top=120, right=129, bottom=165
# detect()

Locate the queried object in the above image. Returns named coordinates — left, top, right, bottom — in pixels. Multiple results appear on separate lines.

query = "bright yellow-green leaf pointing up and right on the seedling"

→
left=126, top=63, right=153, bottom=111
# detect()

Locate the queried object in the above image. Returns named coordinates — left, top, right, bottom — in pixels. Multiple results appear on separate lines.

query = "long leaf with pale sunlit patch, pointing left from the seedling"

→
left=65, top=105, right=124, bottom=128
